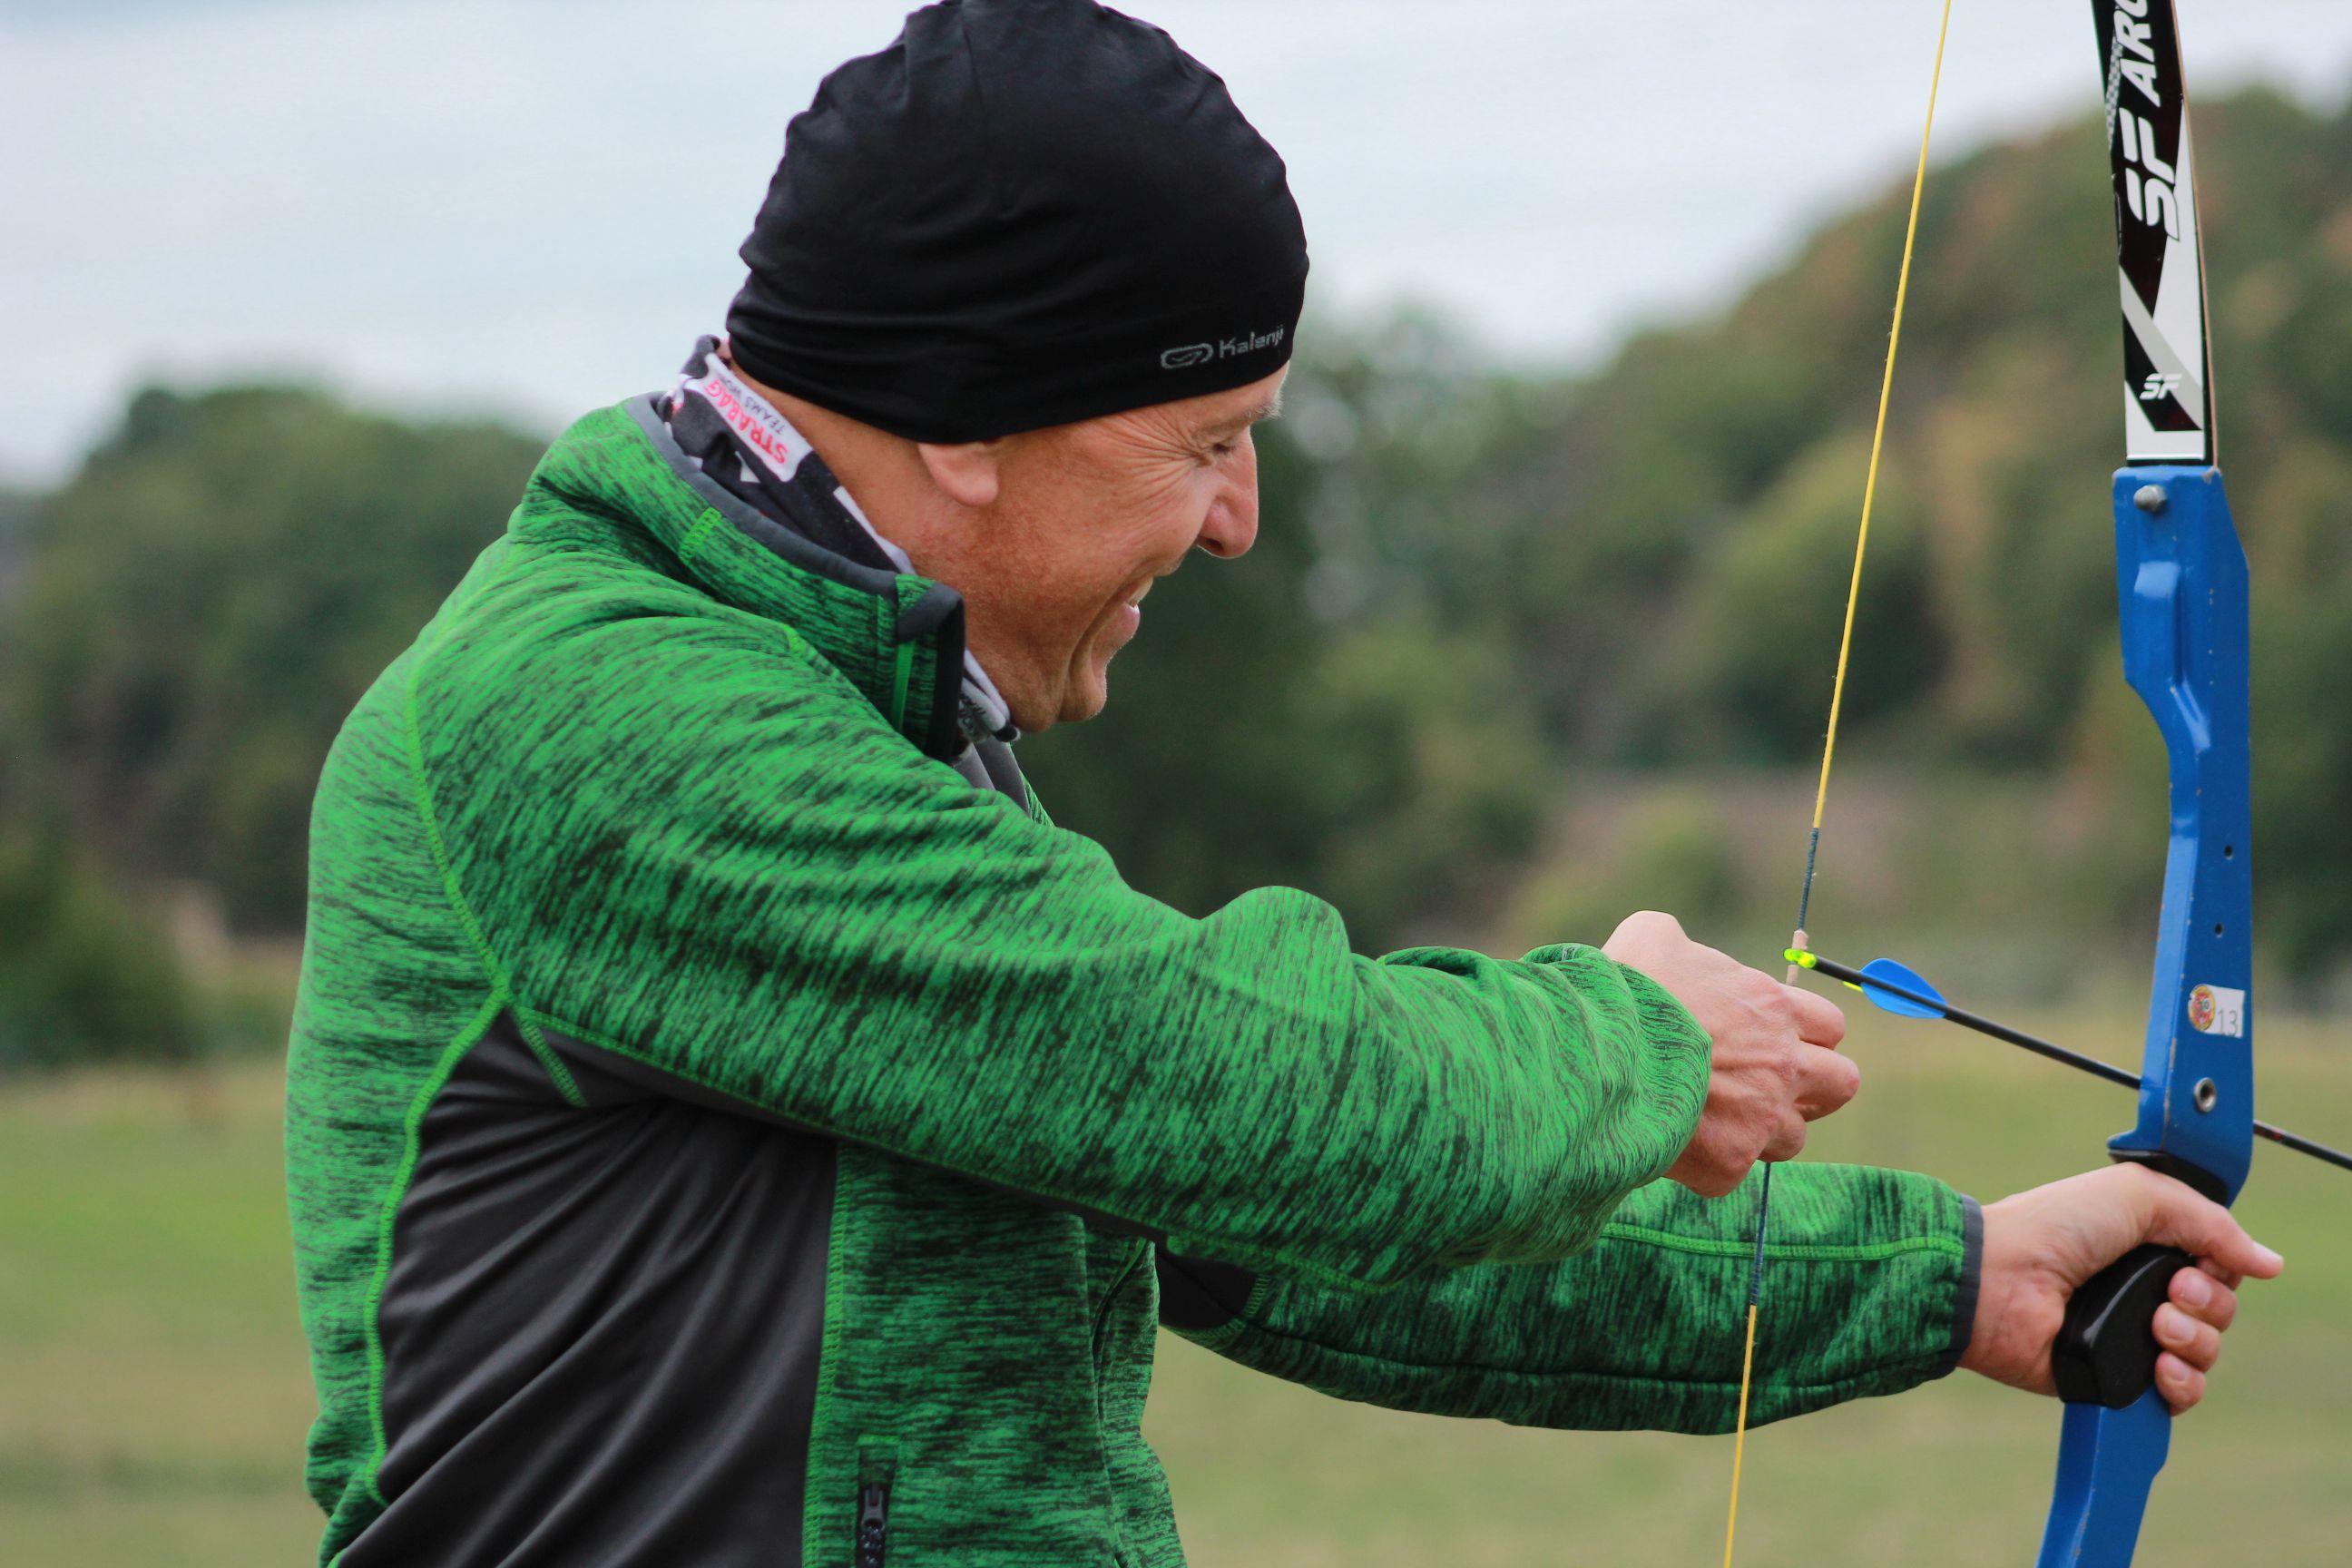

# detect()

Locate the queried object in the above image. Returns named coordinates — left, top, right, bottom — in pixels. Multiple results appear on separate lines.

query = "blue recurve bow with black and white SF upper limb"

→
left=2039, top=0, right=2253, bottom=1568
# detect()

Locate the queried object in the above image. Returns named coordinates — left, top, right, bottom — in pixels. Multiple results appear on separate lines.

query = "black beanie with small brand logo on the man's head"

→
left=727, top=0, right=1308, bottom=442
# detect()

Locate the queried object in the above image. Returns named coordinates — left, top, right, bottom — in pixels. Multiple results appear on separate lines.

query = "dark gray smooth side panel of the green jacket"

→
left=357, top=1018, right=835, bottom=1568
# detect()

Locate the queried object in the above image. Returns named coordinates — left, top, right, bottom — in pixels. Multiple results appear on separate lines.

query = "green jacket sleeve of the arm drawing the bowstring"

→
left=409, top=616, right=1708, bottom=1289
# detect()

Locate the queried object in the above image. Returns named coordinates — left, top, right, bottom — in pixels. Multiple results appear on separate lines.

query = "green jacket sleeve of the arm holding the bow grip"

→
left=1160, top=1163, right=1983, bottom=1432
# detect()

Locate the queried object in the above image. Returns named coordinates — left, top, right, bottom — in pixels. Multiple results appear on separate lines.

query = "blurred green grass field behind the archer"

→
left=0, top=1018, right=2352, bottom=1568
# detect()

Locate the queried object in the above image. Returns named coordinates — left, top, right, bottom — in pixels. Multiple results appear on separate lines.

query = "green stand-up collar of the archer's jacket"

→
left=532, top=393, right=965, bottom=761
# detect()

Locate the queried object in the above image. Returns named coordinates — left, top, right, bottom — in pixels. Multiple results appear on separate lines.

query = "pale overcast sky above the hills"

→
left=0, top=0, right=2352, bottom=482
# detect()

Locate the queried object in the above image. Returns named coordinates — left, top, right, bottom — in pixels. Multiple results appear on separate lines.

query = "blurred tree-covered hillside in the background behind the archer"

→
left=0, top=92, right=2352, bottom=1067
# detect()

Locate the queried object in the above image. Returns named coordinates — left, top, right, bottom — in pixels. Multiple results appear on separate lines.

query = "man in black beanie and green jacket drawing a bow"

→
left=287, top=0, right=2277, bottom=1568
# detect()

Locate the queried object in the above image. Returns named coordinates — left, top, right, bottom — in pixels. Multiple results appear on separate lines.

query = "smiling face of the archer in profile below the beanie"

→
left=934, top=367, right=1287, bottom=731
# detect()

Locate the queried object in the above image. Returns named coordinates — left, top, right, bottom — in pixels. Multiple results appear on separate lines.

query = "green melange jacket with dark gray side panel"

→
left=287, top=399, right=1974, bottom=1568
